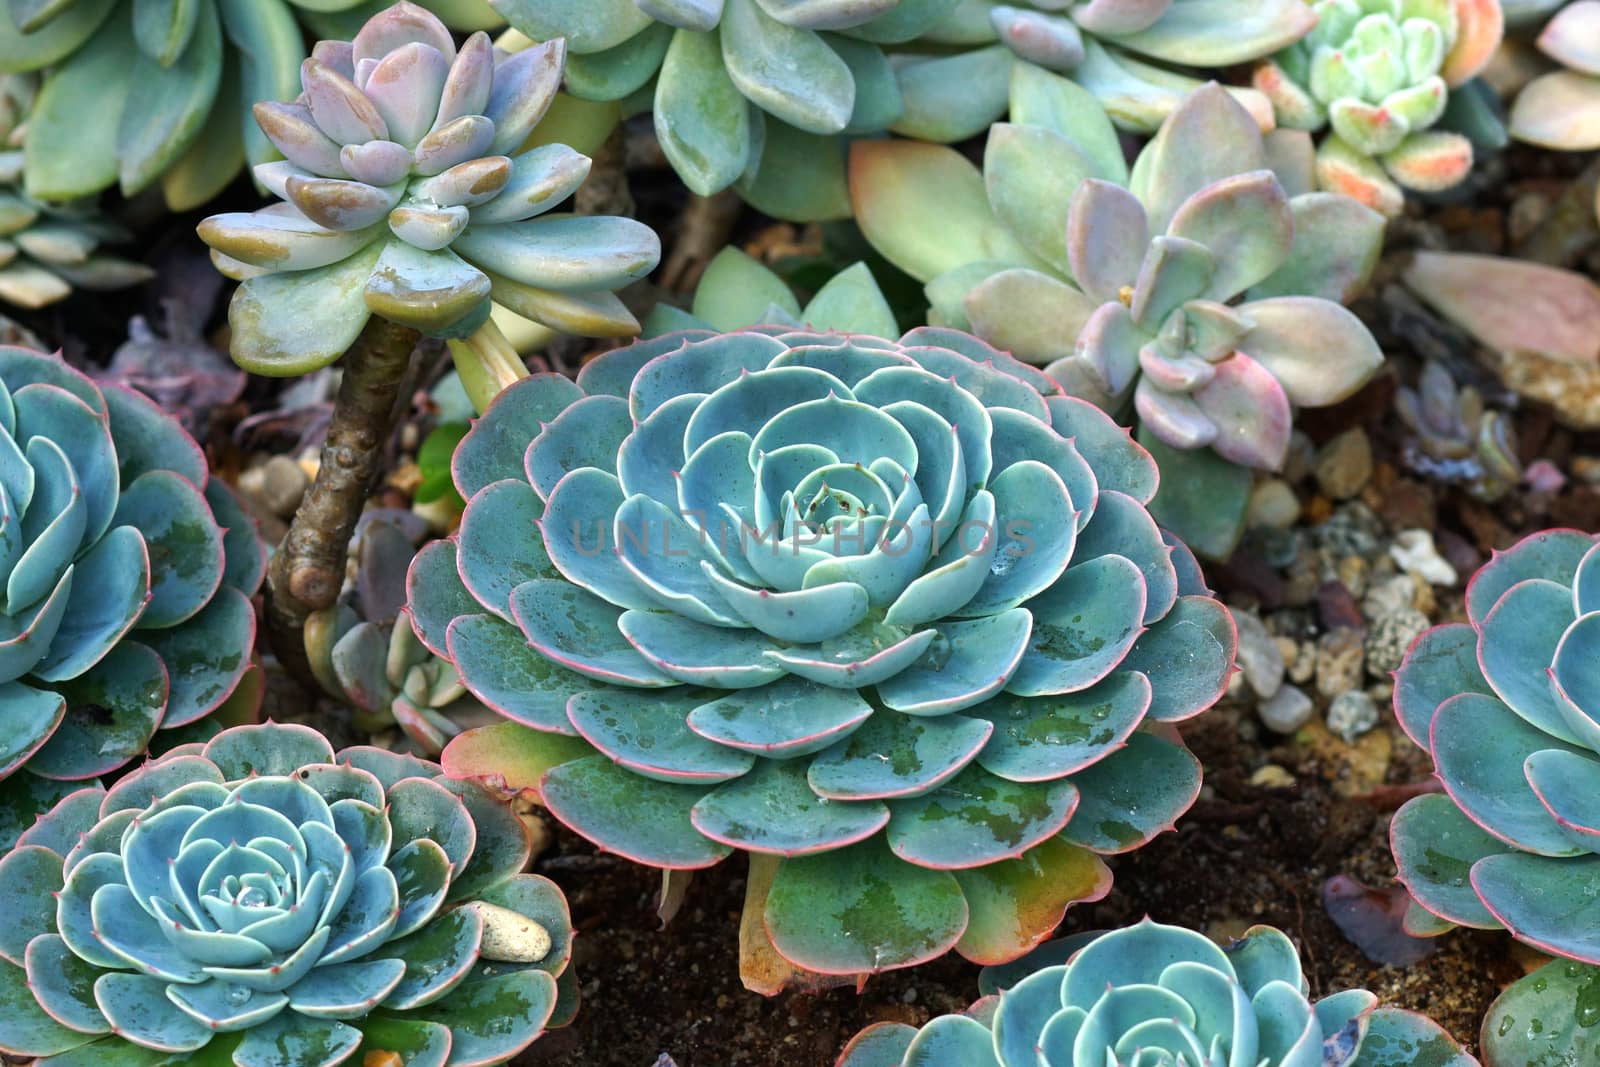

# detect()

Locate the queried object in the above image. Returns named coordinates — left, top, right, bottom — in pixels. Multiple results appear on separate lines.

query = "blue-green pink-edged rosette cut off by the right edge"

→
left=1392, top=530, right=1600, bottom=963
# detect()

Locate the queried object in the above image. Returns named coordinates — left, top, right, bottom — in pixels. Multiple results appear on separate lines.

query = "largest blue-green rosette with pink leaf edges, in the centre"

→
left=408, top=328, right=1235, bottom=974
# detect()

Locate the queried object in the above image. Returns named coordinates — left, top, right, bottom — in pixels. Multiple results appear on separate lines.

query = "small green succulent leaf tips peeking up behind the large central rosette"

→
left=642, top=246, right=899, bottom=338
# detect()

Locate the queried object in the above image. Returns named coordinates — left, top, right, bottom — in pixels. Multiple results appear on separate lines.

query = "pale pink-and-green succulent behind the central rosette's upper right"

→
left=851, top=77, right=1382, bottom=557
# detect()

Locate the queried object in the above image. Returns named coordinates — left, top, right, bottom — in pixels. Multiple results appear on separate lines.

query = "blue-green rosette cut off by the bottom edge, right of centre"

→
left=837, top=920, right=1477, bottom=1067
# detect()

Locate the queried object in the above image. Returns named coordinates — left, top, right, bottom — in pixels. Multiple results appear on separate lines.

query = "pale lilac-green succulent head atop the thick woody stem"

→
left=200, top=3, right=661, bottom=374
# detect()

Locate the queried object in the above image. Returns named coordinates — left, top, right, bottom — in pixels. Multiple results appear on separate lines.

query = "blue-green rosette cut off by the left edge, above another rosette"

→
left=0, top=347, right=266, bottom=806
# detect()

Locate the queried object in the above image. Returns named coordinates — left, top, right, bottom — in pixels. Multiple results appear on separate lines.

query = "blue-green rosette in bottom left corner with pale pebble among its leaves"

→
left=0, top=723, right=576, bottom=1067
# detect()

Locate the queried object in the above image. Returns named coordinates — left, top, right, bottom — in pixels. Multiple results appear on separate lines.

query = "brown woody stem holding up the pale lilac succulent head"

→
left=267, top=315, right=421, bottom=680
